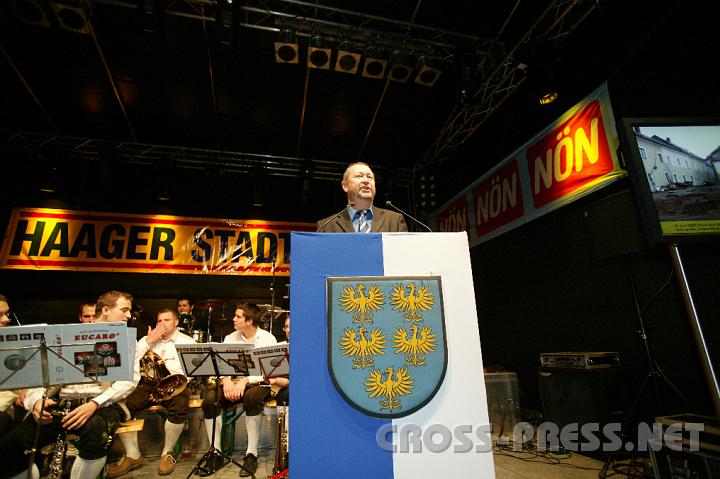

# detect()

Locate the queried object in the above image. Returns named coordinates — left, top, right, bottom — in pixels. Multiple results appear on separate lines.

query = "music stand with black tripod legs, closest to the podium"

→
left=175, top=344, right=256, bottom=479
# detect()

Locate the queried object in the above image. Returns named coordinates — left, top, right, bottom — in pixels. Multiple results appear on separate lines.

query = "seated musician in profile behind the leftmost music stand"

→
left=0, top=291, right=137, bottom=479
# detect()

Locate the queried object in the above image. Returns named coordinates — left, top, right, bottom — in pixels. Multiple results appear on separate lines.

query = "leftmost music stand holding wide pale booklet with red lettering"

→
left=0, top=324, right=132, bottom=478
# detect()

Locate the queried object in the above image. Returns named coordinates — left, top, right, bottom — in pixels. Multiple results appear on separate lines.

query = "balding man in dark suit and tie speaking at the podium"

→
left=317, top=163, right=407, bottom=233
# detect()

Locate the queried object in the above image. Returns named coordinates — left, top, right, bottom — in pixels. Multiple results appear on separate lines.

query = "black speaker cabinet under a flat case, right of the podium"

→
left=539, top=367, right=628, bottom=429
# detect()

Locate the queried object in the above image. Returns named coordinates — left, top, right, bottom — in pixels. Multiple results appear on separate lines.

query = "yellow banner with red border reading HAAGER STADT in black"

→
left=0, top=208, right=315, bottom=276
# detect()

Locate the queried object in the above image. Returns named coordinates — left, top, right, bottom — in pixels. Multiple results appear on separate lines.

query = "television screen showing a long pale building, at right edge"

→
left=620, top=118, right=720, bottom=244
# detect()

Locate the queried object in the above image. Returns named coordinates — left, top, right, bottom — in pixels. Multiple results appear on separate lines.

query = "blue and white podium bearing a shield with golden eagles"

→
left=289, top=233, right=495, bottom=479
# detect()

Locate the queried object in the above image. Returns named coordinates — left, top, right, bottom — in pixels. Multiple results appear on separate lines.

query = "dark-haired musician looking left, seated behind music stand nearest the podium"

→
left=202, top=303, right=277, bottom=477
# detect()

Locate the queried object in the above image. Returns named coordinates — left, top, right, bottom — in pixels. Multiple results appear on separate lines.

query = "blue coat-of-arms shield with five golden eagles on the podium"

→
left=327, top=276, right=447, bottom=418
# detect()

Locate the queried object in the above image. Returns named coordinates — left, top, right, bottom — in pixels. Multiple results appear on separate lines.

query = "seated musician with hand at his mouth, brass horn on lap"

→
left=107, top=309, right=195, bottom=478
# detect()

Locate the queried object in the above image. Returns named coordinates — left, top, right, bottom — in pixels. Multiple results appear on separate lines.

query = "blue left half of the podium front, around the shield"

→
left=289, top=233, right=393, bottom=479
